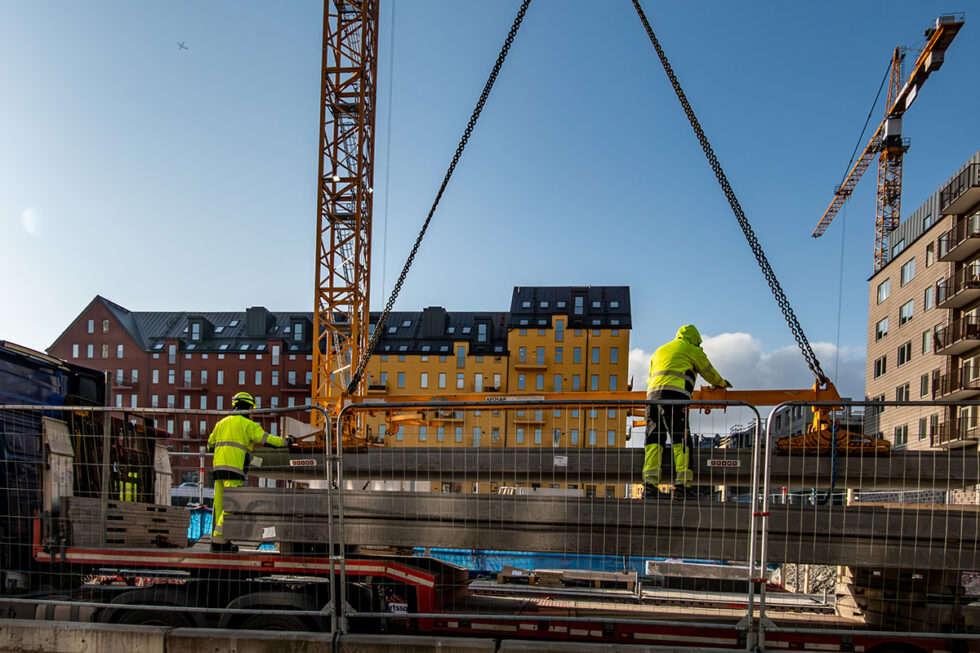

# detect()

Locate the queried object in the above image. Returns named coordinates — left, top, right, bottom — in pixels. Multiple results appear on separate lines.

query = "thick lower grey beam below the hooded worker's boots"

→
left=225, top=488, right=980, bottom=570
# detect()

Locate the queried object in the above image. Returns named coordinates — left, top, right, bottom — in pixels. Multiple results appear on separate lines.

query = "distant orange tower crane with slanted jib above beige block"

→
left=813, top=14, right=964, bottom=272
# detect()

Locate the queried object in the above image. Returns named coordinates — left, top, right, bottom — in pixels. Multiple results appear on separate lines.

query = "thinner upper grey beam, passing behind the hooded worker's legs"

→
left=252, top=447, right=980, bottom=490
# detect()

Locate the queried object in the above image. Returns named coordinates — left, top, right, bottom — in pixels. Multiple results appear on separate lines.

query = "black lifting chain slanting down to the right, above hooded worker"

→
left=633, top=0, right=827, bottom=385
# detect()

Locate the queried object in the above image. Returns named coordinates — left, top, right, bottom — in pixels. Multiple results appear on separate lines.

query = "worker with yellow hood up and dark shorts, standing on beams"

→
left=643, top=324, right=732, bottom=499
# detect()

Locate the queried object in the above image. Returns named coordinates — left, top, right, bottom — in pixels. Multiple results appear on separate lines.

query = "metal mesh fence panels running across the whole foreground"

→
left=0, top=400, right=980, bottom=649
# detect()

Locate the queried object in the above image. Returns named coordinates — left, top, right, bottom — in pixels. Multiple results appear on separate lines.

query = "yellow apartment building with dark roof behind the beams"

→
left=358, top=286, right=631, bottom=497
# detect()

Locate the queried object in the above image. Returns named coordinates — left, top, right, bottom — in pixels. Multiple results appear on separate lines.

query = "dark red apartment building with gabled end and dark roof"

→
left=48, top=296, right=312, bottom=482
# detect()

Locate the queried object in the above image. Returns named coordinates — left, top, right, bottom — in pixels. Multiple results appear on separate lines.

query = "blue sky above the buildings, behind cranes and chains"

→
left=0, top=0, right=980, bottom=397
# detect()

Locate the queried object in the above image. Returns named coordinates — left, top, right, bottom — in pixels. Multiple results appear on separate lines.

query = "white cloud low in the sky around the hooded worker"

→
left=629, top=333, right=865, bottom=401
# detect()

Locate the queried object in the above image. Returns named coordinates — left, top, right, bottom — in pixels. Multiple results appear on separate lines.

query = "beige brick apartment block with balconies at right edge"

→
left=865, top=152, right=980, bottom=449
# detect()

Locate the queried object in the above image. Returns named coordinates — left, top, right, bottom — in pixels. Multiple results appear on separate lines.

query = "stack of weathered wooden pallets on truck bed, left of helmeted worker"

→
left=62, top=497, right=190, bottom=548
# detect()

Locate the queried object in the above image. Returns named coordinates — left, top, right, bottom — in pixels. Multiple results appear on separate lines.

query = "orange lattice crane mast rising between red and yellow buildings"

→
left=314, top=0, right=378, bottom=428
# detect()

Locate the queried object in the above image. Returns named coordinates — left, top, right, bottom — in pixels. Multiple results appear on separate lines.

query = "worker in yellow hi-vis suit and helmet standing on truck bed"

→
left=208, top=392, right=290, bottom=551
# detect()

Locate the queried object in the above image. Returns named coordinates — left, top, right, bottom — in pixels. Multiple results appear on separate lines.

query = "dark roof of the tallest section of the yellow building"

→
left=507, top=286, right=632, bottom=329
